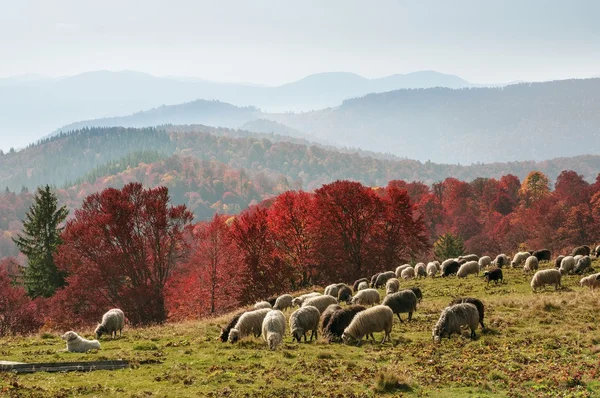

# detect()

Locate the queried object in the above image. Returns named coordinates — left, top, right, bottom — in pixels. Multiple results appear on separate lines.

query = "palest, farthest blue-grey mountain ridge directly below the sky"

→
left=0, top=71, right=470, bottom=149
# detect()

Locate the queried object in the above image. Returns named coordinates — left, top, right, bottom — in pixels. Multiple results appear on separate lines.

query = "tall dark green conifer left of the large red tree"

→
left=13, top=185, right=69, bottom=297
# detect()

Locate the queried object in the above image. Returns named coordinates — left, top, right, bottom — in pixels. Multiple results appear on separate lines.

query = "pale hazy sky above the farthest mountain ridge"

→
left=0, top=0, right=600, bottom=84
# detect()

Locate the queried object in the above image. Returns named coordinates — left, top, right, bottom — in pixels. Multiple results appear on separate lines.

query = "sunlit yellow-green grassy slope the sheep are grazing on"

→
left=0, top=264, right=600, bottom=398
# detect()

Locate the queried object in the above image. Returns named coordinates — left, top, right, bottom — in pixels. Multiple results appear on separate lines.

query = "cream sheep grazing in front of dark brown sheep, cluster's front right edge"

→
left=342, top=305, right=394, bottom=345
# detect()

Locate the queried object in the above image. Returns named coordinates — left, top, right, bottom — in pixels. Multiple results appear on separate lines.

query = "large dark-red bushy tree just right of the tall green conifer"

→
left=57, top=183, right=192, bottom=324
